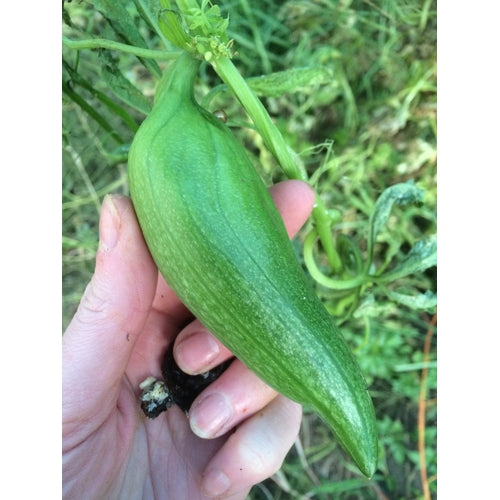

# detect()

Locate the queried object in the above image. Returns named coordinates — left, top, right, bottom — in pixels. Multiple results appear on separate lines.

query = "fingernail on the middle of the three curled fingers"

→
left=189, top=393, right=233, bottom=439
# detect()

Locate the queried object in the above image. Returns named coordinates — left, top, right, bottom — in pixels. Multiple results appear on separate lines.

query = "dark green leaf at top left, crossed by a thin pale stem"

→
left=90, top=0, right=162, bottom=77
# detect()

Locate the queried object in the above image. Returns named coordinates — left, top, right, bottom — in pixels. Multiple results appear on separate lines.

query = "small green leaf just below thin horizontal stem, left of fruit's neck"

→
left=100, top=52, right=152, bottom=115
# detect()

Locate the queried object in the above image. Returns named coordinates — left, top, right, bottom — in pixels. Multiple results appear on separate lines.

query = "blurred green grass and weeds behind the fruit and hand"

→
left=62, top=0, right=437, bottom=500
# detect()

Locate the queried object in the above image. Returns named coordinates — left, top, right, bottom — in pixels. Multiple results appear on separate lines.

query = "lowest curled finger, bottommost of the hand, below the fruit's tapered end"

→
left=202, top=396, right=302, bottom=498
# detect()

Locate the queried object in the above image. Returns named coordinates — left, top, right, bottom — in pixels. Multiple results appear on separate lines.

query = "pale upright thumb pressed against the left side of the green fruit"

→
left=62, top=195, right=158, bottom=421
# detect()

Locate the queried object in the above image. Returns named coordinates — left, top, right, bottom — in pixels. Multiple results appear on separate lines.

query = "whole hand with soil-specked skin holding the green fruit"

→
left=62, top=181, right=314, bottom=500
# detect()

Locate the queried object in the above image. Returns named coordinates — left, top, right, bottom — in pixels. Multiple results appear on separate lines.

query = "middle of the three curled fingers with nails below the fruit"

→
left=189, top=360, right=277, bottom=439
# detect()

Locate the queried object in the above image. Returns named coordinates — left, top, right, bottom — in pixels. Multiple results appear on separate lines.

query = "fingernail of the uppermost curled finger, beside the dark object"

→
left=175, top=332, right=220, bottom=375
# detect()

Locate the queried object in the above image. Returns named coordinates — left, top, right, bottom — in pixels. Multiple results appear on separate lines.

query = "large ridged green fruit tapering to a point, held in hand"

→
left=129, top=54, right=378, bottom=477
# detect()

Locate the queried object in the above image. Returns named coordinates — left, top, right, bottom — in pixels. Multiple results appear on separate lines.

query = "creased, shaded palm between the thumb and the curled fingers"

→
left=64, top=277, right=232, bottom=499
